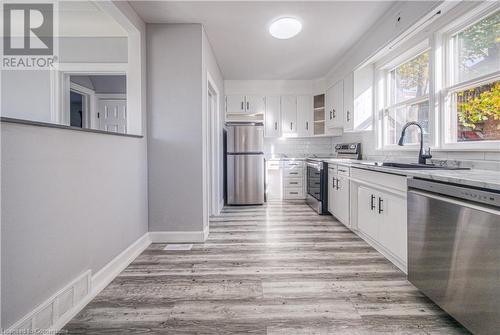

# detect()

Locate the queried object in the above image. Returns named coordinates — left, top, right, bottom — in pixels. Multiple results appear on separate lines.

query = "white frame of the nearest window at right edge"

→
left=434, top=3, right=500, bottom=151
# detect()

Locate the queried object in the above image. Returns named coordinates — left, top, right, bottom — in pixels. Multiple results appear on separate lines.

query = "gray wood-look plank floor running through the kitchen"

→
left=65, top=202, right=467, bottom=335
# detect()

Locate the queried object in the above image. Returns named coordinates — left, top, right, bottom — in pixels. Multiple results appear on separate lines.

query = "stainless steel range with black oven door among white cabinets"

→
left=306, top=143, right=361, bottom=214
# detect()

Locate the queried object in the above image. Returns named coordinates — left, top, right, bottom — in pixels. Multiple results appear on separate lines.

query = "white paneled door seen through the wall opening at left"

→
left=97, top=99, right=127, bottom=134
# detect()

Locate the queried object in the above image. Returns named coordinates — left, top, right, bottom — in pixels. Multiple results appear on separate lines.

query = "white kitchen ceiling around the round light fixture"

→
left=131, top=1, right=394, bottom=80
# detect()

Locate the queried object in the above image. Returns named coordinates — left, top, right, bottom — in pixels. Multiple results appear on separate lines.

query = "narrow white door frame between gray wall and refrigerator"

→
left=207, top=71, right=223, bottom=216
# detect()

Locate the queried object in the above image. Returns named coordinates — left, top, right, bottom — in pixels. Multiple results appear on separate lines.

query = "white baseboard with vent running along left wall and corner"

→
left=7, top=226, right=213, bottom=333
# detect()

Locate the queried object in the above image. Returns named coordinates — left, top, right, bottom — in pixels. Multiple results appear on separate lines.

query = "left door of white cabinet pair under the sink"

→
left=358, top=186, right=380, bottom=240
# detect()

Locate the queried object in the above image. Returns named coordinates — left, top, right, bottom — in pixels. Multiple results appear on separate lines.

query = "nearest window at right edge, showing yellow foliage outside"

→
left=444, top=10, right=500, bottom=144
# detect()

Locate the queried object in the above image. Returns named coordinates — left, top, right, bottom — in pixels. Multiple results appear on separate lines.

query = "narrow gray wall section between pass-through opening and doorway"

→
left=147, top=24, right=203, bottom=231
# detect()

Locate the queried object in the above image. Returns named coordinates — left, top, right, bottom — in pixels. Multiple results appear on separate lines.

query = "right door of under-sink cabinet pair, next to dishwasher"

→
left=376, top=193, right=407, bottom=262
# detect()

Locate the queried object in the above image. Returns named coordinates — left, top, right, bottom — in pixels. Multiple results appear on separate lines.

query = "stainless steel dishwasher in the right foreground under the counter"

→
left=408, top=179, right=500, bottom=334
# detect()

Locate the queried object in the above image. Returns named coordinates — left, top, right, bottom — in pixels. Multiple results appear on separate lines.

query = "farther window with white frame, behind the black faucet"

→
left=382, top=50, right=430, bottom=146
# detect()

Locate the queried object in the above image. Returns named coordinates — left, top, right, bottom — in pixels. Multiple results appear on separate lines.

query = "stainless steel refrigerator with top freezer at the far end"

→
left=225, top=123, right=264, bottom=205
